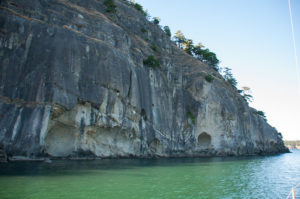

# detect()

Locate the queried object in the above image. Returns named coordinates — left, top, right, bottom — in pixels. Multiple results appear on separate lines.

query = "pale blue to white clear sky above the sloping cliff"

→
left=136, top=0, right=300, bottom=140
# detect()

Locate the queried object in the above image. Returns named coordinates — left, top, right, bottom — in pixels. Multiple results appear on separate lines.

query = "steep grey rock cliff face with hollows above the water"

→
left=0, top=0, right=286, bottom=157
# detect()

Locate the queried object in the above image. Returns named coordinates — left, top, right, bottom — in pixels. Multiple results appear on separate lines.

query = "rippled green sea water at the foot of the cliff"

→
left=0, top=150, right=300, bottom=199
